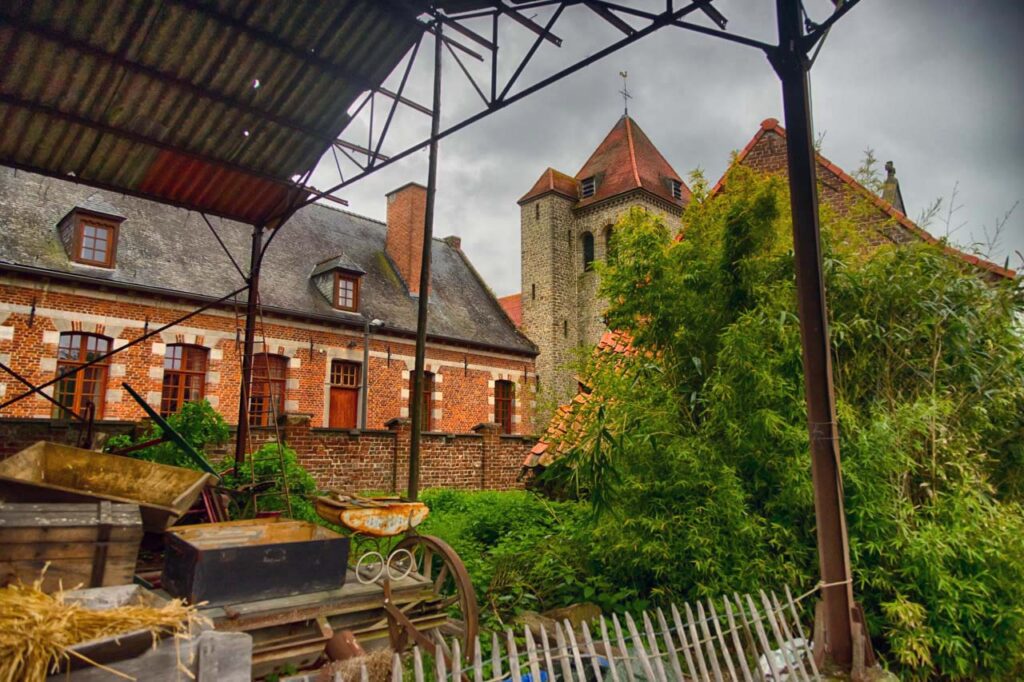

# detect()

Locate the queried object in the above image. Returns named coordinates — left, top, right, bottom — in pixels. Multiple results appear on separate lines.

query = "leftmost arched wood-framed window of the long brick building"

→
left=53, top=332, right=111, bottom=419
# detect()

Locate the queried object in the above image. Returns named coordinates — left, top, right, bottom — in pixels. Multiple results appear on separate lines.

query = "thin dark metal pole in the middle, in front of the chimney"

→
left=409, top=15, right=442, bottom=500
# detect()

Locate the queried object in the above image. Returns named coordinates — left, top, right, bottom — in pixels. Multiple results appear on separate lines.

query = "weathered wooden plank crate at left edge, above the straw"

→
left=0, top=501, right=142, bottom=592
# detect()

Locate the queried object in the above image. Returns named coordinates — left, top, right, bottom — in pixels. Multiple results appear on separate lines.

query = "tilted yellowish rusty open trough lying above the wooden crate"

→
left=0, top=440, right=212, bottom=532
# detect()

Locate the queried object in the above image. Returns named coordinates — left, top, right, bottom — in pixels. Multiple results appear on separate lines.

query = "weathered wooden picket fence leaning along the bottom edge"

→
left=356, top=588, right=821, bottom=682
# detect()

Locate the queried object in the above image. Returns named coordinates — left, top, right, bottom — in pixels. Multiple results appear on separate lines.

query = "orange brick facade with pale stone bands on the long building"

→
left=0, top=274, right=536, bottom=433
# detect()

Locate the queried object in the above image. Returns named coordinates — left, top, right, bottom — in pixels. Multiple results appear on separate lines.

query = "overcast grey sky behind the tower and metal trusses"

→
left=313, top=0, right=1024, bottom=295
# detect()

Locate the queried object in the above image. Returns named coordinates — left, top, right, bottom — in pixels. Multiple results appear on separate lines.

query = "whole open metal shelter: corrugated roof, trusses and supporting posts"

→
left=0, top=0, right=872, bottom=673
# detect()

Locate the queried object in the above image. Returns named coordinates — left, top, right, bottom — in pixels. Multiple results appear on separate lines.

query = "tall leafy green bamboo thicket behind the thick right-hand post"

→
left=546, top=168, right=1024, bottom=679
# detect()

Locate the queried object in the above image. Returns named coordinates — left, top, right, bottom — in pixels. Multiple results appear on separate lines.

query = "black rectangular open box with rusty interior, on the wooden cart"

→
left=162, top=518, right=349, bottom=605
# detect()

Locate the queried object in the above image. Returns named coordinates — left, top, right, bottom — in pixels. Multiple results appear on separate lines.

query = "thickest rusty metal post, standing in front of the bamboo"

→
left=769, top=0, right=859, bottom=671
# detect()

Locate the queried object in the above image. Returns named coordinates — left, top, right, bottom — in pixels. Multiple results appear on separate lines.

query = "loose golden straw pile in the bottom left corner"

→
left=0, top=581, right=203, bottom=682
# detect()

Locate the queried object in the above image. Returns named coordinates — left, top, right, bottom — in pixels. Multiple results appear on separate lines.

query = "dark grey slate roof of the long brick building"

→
left=0, top=168, right=537, bottom=356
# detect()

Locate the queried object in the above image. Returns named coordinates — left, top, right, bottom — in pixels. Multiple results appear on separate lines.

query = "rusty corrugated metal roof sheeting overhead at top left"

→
left=0, top=0, right=423, bottom=224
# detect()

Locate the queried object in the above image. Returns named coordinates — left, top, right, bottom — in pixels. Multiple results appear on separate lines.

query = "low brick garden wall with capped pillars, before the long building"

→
left=0, top=414, right=534, bottom=492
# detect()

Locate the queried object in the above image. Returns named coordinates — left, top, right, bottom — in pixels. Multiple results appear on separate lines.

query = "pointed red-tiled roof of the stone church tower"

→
left=519, top=116, right=690, bottom=208
